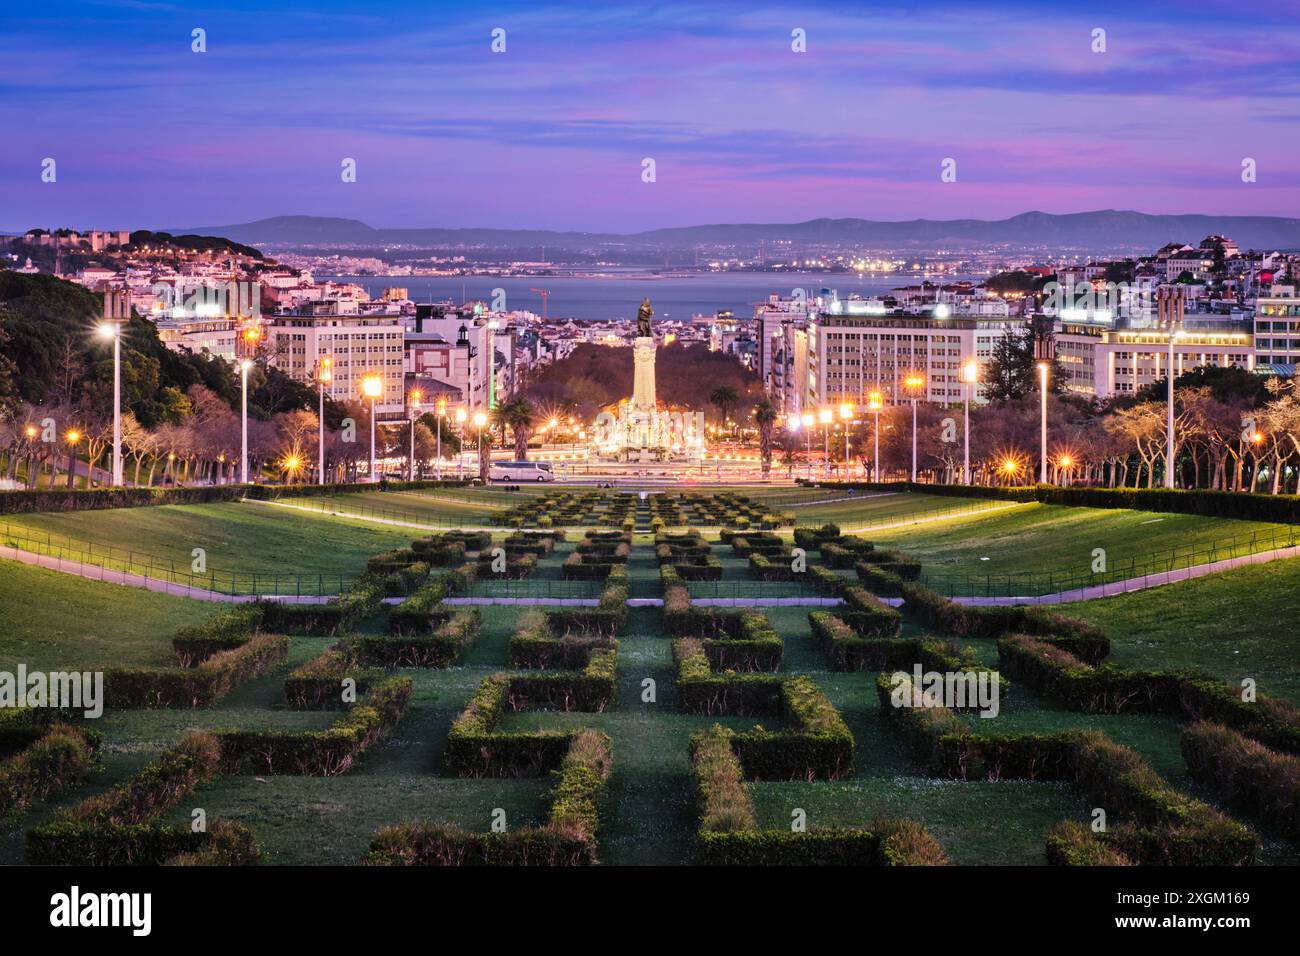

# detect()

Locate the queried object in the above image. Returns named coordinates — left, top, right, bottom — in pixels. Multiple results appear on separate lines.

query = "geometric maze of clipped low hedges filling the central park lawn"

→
left=10, top=489, right=1300, bottom=866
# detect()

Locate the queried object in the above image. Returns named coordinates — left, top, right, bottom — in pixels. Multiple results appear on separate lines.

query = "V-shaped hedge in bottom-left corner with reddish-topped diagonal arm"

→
left=26, top=732, right=257, bottom=866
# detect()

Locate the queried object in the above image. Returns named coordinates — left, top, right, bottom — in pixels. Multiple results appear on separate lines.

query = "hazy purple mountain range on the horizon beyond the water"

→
left=165, top=209, right=1300, bottom=251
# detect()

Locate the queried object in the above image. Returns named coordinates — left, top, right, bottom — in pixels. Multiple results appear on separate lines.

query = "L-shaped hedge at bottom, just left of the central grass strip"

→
left=365, top=730, right=611, bottom=866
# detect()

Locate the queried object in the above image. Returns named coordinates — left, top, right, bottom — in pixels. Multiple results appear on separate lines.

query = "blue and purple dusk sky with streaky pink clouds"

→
left=0, top=0, right=1300, bottom=232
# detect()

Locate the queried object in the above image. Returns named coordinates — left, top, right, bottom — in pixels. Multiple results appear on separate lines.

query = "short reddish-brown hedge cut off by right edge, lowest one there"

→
left=1182, top=721, right=1300, bottom=838
